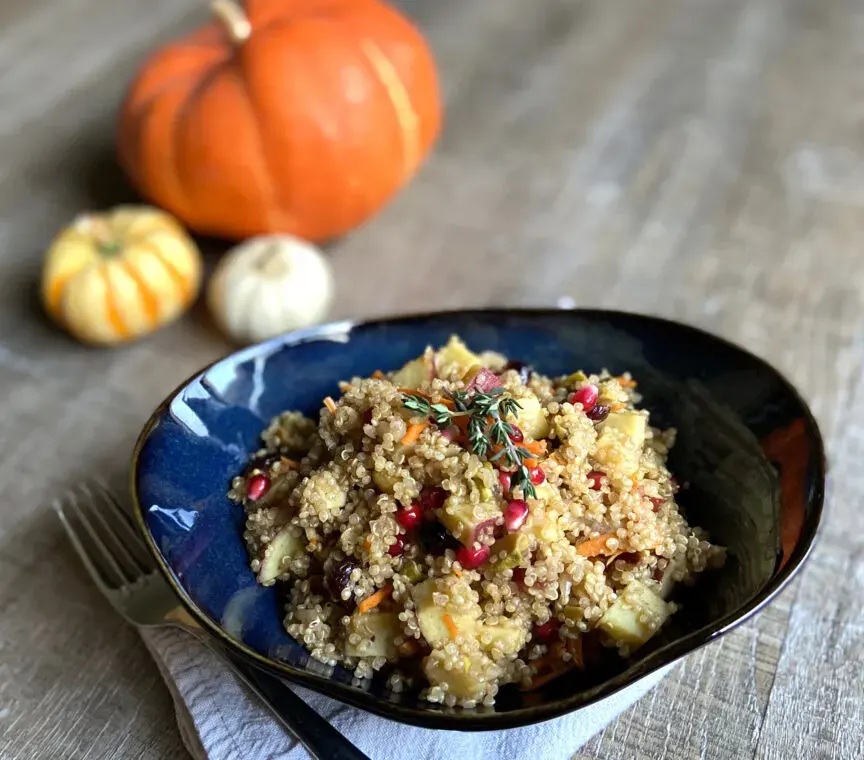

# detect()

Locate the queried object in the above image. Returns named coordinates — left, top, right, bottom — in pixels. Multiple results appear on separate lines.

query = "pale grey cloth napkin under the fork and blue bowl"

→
left=142, top=629, right=671, bottom=760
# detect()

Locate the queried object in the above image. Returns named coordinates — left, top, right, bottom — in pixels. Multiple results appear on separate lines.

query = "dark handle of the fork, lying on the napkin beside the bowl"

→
left=218, top=646, right=369, bottom=760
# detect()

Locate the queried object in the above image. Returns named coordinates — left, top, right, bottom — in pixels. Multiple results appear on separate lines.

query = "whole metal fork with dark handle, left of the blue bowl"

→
left=53, top=482, right=369, bottom=760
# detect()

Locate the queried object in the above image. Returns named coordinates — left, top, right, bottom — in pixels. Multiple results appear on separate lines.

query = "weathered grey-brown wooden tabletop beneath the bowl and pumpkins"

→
left=0, top=0, right=864, bottom=760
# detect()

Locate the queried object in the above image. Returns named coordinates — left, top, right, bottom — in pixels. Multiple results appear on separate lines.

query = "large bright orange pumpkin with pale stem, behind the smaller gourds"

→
left=118, top=0, right=440, bottom=241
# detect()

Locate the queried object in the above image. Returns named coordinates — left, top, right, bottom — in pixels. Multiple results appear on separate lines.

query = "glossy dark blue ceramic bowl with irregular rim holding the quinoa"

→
left=132, top=310, right=825, bottom=730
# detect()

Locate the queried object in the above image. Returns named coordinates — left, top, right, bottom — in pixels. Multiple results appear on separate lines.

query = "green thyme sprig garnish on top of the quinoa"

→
left=402, top=386, right=537, bottom=498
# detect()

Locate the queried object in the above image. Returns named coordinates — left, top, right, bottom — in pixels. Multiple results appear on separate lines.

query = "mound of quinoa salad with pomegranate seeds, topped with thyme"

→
left=229, top=336, right=724, bottom=707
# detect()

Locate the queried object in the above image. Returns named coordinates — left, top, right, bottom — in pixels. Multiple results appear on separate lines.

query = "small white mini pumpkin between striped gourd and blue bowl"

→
left=207, top=235, right=333, bottom=343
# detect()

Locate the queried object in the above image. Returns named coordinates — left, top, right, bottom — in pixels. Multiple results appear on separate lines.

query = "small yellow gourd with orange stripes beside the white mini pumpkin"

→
left=42, top=206, right=202, bottom=345
